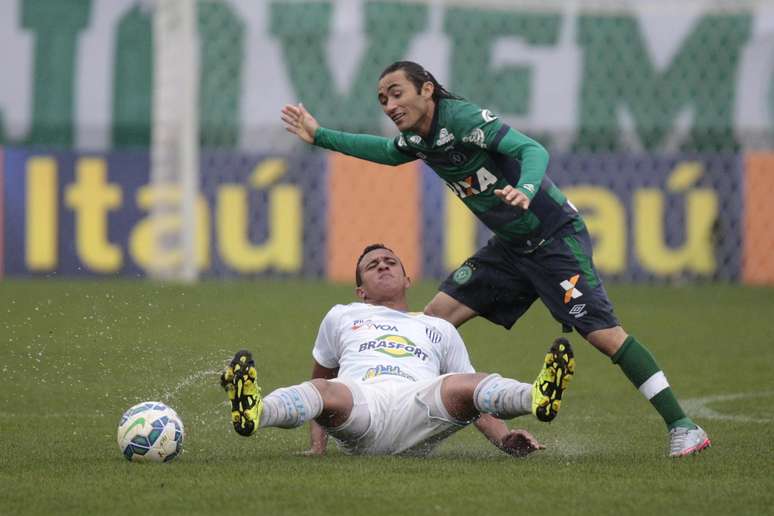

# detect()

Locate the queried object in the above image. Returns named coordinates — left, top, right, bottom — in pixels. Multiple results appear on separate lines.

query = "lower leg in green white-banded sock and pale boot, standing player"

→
left=612, top=335, right=711, bottom=457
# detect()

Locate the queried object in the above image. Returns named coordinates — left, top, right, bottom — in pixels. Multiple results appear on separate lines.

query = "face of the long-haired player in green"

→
left=378, top=70, right=435, bottom=136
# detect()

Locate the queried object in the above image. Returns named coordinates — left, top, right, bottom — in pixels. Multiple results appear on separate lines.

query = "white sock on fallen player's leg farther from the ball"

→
left=473, top=374, right=532, bottom=419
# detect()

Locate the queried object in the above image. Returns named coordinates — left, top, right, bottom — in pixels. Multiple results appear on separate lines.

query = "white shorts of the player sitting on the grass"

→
left=327, top=375, right=470, bottom=456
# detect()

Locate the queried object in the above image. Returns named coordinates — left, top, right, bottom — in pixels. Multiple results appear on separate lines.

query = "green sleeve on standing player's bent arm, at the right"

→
left=454, top=103, right=548, bottom=199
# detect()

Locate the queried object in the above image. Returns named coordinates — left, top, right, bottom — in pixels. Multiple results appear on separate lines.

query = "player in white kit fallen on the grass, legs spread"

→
left=221, top=244, right=575, bottom=456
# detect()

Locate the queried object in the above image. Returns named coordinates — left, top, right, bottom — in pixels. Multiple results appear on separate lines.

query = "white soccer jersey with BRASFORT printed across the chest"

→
left=312, top=303, right=475, bottom=381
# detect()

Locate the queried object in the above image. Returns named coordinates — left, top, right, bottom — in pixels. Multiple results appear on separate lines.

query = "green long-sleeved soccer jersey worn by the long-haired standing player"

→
left=315, top=99, right=580, bottom=251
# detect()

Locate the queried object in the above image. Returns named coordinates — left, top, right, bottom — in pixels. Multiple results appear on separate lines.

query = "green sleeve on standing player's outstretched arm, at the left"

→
left=314, top=127, right=416, bottom=166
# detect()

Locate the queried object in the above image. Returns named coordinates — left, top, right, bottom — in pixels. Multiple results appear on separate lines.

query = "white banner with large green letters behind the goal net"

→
left=0, top=0, right=774, bottom=152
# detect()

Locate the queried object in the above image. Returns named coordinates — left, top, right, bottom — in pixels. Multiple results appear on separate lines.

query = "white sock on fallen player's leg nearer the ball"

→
left=258, top=382, right=323, bottom=428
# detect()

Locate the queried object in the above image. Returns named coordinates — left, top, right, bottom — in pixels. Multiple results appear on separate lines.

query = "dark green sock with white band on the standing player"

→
left=612, top=335, right=696, bottom=430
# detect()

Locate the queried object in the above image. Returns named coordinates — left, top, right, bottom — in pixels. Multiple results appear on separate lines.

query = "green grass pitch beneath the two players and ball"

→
left=0, top=280, right=774, bottom=516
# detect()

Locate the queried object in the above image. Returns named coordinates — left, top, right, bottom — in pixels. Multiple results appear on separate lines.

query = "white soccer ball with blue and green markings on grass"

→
left=116, top=401, right=185, bottom=462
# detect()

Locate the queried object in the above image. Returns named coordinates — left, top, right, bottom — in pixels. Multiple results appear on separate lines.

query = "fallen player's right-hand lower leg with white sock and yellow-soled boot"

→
left=473, top=338, right=575, bottom=421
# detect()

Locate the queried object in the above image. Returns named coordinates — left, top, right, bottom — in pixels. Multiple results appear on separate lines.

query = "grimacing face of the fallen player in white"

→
left=357, top=249, right=409, bottom=303
